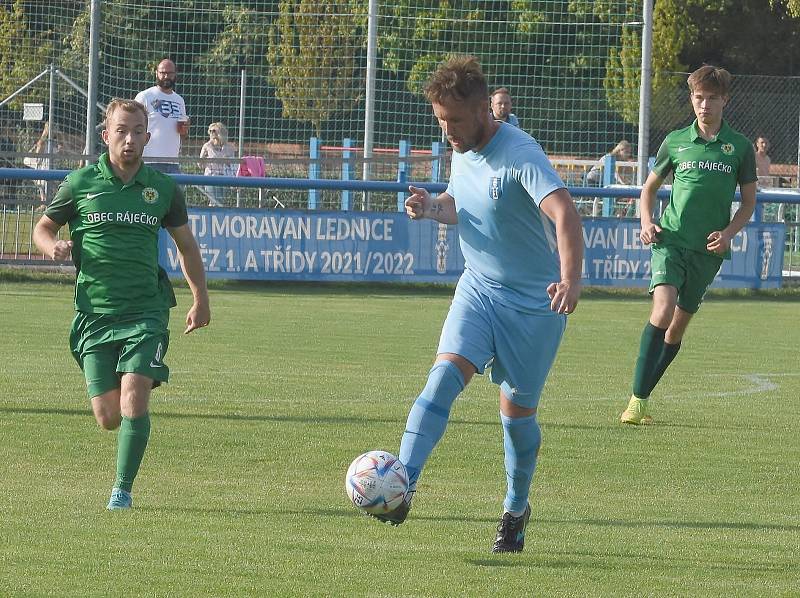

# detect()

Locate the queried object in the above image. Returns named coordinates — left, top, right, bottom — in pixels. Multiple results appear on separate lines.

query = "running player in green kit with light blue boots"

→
left=33, top=99, right=211, bottom=510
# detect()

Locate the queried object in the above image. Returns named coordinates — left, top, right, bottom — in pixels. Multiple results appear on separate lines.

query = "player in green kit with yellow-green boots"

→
left=620, top=65, right=757, bottom=424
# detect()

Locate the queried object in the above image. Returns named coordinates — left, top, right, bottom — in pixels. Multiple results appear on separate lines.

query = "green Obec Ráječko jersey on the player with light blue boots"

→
left=45, top=154, right=188, bottom=314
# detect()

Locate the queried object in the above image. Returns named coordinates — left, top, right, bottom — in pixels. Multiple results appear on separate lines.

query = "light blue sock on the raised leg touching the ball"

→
left=399, top=360, right=464, bottom=490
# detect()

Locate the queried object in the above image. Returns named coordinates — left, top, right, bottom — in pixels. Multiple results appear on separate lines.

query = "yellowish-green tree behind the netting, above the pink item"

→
left=267, top=0, right=366, bottom=136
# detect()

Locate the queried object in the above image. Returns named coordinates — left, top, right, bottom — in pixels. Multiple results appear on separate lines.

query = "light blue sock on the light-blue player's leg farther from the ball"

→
left=500, top=413, right=542, bottom=513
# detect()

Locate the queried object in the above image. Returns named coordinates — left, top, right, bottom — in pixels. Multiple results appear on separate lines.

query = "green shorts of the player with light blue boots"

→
left=69, top=310, right=169, bottom=398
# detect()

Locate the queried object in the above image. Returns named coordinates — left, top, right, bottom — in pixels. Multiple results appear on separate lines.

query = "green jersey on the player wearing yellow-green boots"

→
left=653, top=120, right=757, bottom=257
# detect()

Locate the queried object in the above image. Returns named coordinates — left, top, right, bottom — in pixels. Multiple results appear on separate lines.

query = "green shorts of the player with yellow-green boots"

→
left=650, top=245, right=722, bottom=314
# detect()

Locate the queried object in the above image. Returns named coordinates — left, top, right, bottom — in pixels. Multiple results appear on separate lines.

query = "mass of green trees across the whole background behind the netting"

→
left=0, top=0, right=800, bottom=155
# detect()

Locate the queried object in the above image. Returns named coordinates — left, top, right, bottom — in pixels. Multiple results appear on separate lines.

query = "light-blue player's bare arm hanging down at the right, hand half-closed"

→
left=539, top=188, right=583, bottom=314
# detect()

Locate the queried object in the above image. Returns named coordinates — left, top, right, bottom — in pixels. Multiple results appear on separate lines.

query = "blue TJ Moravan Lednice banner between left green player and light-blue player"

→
left=160, top=208, right=464, bottom=283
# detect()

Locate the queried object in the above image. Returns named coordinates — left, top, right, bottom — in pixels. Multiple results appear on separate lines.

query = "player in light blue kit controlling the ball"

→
left=377, top=56, right=583, bottom=552
